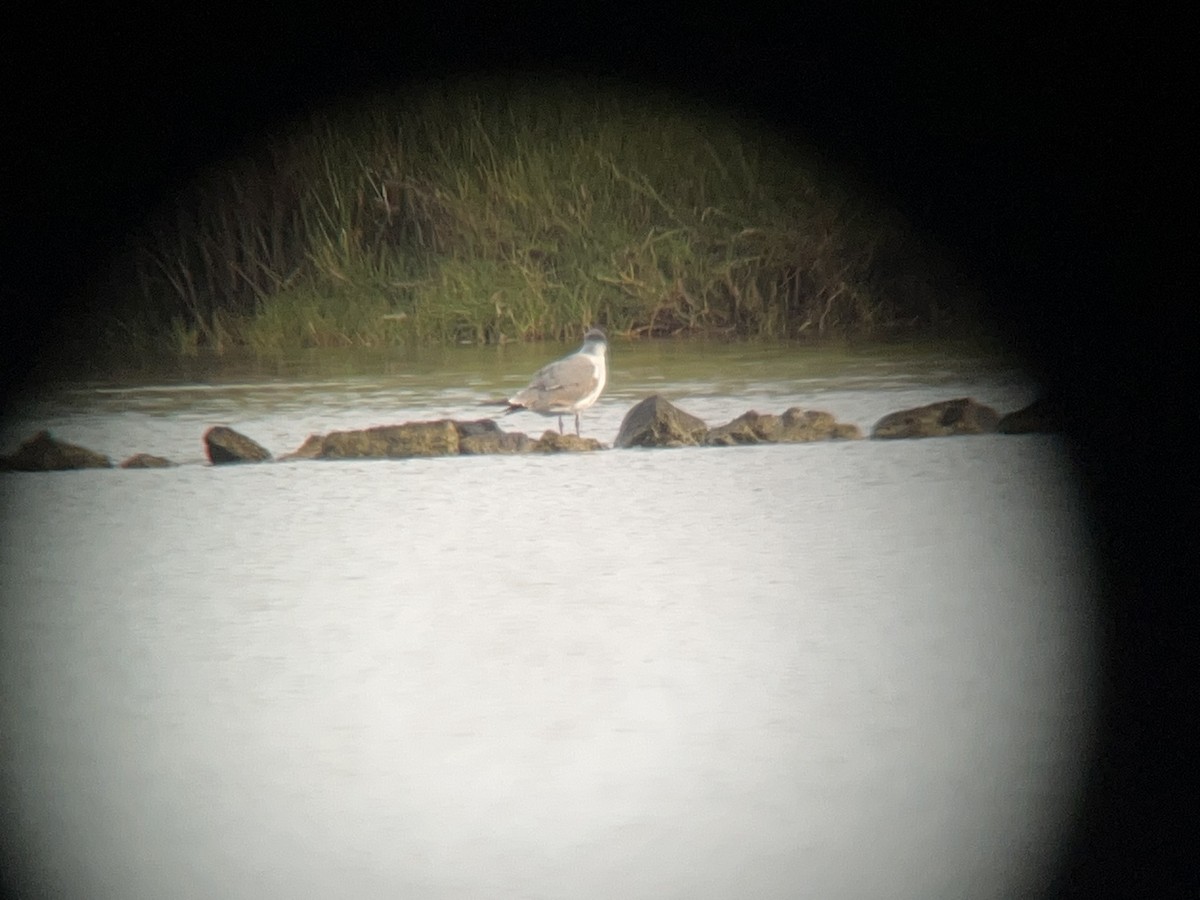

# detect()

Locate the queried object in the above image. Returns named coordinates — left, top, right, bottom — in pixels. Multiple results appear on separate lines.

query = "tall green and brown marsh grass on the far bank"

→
left=77, top=83, right=984, bottom=354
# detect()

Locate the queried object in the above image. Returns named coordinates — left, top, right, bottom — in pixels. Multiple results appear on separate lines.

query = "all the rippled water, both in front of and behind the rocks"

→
left=0, top=346, right=1096, bottom=898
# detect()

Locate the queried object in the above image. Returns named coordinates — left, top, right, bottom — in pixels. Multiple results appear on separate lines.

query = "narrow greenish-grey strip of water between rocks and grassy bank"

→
left=0, top=341, right=1037, bottom=463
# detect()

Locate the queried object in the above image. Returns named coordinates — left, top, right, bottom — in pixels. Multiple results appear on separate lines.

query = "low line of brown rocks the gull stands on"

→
left=0, top=395, right=1063, bottom=472
